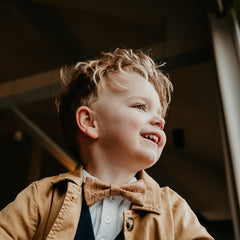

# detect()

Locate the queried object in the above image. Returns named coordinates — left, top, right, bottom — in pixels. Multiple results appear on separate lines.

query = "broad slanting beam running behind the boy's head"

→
left=0, top=46, right=213, bottom=109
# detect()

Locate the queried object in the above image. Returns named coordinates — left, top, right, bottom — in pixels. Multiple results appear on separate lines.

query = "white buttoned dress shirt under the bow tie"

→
left=83, top=169, right=137, bottom=240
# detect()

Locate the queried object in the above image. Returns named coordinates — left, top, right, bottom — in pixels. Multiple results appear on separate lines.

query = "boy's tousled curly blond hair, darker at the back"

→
left=55, top=48, right=173, bottom=160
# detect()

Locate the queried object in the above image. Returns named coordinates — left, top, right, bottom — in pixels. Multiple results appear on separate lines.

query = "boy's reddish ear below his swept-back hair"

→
left=75, top=106, right=98, bottom=139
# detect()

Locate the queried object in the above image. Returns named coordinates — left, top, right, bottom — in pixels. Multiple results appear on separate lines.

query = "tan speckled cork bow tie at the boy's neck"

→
left=84, top=177, right=146, bottom=206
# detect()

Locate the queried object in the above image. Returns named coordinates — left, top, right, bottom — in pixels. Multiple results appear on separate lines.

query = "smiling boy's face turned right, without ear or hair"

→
left=93, top=73, right=166, bottom=172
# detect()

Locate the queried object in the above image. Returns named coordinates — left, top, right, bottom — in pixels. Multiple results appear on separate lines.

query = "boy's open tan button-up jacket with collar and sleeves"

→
left=0, top=167, right=213, bottom=240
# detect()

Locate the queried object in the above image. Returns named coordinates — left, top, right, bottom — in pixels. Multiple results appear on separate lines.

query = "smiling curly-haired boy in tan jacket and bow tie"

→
left=0, top=49, right=213, bottom=240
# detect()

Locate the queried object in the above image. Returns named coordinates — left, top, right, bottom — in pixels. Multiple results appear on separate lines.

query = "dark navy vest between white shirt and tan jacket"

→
left=74, top=190, right=124, bottom=240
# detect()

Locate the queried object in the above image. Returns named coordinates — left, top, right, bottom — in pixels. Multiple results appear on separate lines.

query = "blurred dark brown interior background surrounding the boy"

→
left=0, top=0, right=238, bottom=240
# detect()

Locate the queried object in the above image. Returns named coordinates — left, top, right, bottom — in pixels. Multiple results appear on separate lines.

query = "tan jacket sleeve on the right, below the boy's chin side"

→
left=172, top=193, right=213, bottom=240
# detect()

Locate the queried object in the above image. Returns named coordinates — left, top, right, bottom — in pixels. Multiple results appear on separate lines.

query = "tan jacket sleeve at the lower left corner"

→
left=0, top=183, right=38, bottom=240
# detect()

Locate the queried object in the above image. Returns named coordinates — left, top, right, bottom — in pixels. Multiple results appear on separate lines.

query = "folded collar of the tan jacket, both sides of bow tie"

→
left=52, top=165, right=161, bottom=214
